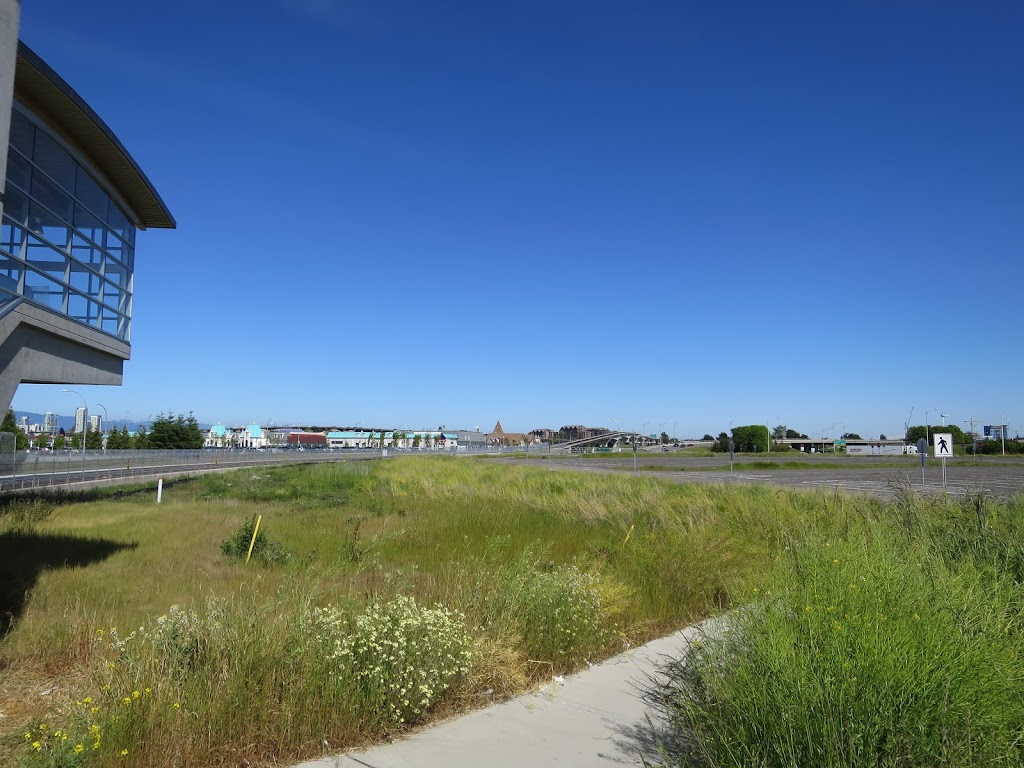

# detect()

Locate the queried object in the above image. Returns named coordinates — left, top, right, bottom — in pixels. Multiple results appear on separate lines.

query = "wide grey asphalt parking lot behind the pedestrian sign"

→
left=505, top=452, right=1024, bottom=499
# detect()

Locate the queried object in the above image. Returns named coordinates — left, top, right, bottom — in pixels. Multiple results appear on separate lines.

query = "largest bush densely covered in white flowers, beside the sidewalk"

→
left=313, top=597, right=472, bottom=725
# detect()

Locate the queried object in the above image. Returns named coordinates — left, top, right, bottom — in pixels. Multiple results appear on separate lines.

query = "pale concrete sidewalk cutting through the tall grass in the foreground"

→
left=296, top=627, right=701, bottom=768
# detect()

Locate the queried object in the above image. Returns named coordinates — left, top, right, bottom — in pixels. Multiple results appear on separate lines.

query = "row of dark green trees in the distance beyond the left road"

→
left=0, top=409, right=204, bottom=451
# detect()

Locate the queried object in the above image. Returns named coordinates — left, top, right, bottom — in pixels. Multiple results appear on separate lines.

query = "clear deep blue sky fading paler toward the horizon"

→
left=13, top=0, right=1024, bottom=436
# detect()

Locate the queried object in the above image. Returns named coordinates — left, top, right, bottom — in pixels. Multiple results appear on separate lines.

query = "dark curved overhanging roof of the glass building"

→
left=14, top=40, right=177, bottom=229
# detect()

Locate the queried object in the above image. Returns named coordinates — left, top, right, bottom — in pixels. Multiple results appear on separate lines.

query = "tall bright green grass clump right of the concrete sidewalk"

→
left=667, top=493, right=1024, bottom=768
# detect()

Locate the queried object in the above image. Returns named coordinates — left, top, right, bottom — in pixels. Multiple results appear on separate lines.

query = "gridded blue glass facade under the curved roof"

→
left=0, top=102, right=135, bottom=342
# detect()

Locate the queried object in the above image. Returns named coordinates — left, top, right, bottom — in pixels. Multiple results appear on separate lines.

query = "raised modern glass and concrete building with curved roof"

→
left=0, top=22, right=175, bottom=410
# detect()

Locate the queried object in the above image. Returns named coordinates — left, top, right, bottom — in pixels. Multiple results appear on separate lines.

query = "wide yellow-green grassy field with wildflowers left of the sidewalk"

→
left=0, top=458, right=1021, bottom=767
